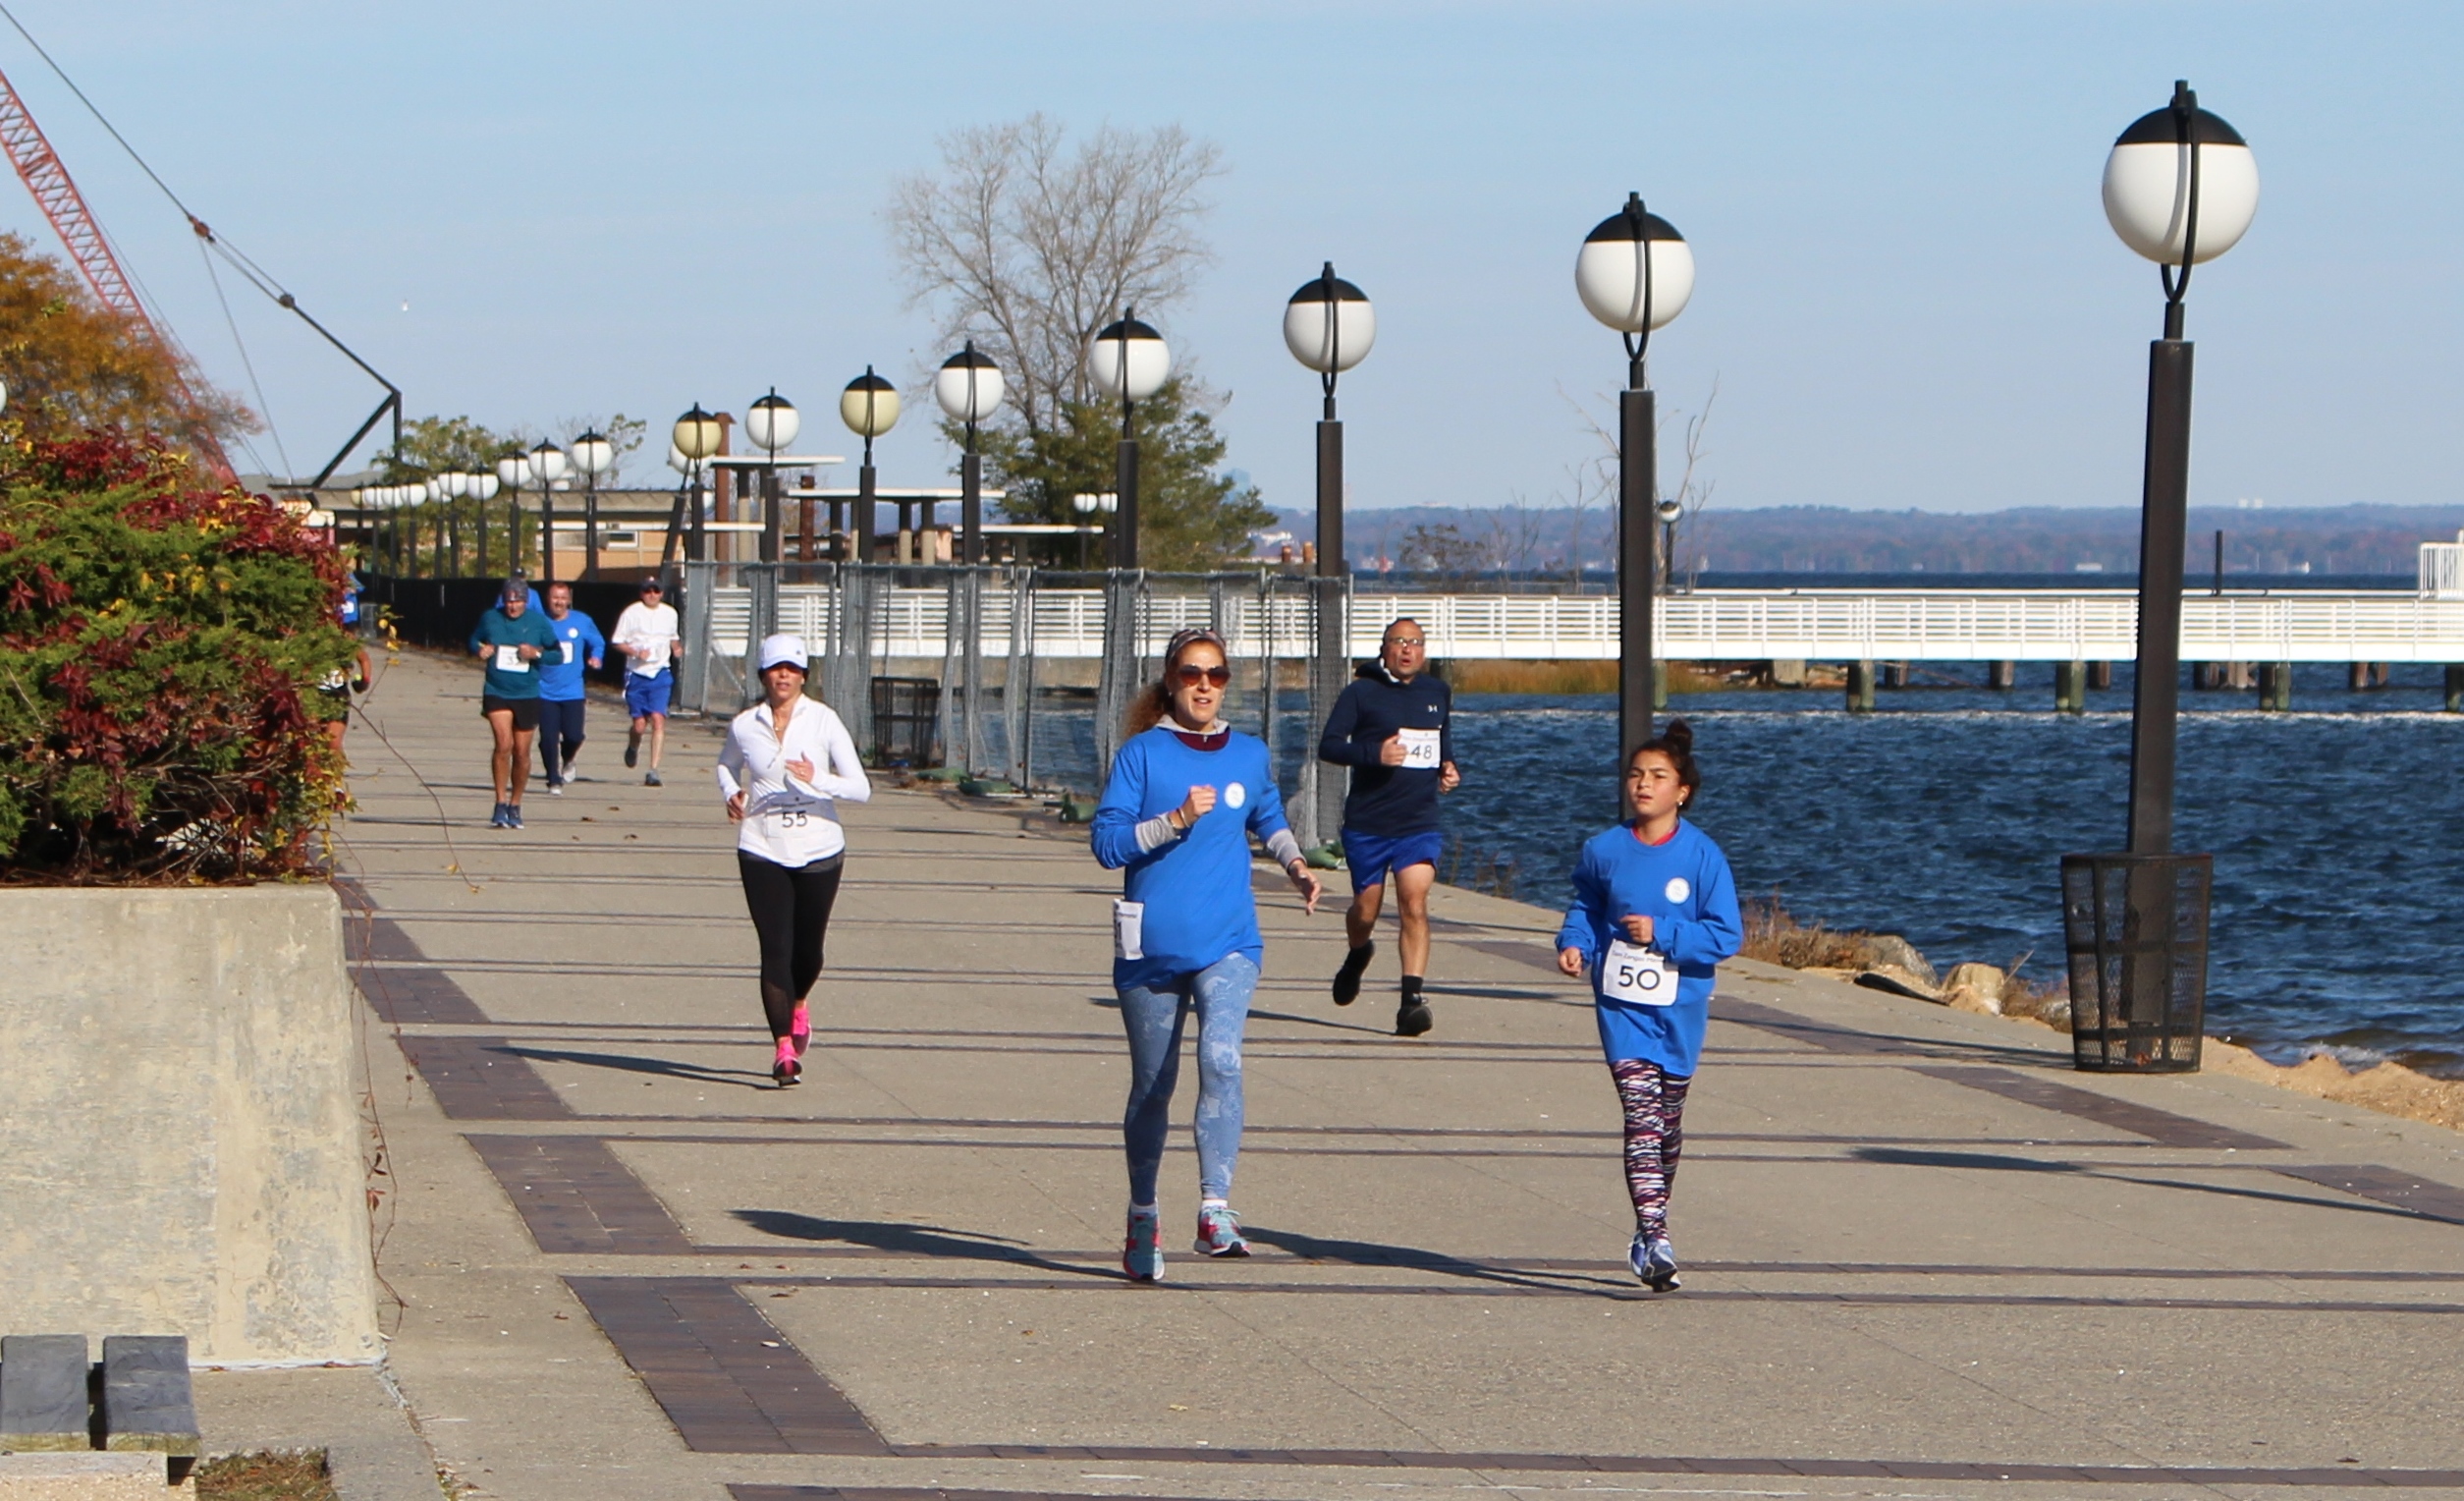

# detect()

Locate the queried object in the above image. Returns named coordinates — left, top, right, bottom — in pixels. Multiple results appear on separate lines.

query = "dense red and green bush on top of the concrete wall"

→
left=0, top=424, right=355, bottom=882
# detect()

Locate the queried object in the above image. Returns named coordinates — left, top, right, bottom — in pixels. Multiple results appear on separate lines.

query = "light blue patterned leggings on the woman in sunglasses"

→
left=1122, top=954, right=1257, bottom=1202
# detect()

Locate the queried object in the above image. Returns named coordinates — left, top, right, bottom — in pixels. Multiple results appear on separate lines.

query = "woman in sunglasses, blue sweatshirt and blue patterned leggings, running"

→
left=1089, top=631, right=1318, bottom=1282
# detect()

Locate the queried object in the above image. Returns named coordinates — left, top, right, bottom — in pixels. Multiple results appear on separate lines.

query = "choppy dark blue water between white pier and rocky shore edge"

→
left=1442, top=663, right=2464, bottom=1077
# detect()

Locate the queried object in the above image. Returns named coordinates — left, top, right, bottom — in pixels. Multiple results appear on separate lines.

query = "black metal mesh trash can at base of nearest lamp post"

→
left=2062, top=856, right=2213, bottom=1075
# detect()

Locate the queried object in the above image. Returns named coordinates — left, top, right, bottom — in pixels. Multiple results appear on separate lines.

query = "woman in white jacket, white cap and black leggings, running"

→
left=720, top=636, right=872, bottom=1074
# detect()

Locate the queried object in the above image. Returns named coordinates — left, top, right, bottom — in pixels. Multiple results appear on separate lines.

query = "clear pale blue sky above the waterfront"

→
left=0, top=0, right=2464, bottom=510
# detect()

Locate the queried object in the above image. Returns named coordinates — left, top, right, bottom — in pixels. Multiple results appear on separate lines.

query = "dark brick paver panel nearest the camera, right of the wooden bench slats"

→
left=565, top=1277, right=890, bottom=1454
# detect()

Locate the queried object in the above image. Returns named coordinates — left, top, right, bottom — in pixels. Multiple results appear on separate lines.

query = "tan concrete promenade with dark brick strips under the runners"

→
left=298, top=655, right=2464, bottom=1501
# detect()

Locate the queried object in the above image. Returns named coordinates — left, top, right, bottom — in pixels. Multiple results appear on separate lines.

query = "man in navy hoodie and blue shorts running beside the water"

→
left=1318, top=616, right=1461, bottom=1037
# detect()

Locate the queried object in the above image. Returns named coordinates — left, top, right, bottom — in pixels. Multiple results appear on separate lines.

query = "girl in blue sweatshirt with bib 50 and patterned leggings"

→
left=1558, top=720, right=1744, bottom=1292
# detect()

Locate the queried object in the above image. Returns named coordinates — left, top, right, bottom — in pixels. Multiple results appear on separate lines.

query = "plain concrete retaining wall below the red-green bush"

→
left=0, top=885, right=377, bottom=1362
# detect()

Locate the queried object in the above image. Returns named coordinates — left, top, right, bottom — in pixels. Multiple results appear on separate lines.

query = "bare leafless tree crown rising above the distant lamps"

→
left=885, top=113, right=1225, bottom=434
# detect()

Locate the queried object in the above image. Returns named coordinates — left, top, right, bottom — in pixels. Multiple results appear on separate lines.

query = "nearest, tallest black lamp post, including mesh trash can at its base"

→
left=2062, top=82, right=2260, bottom=1072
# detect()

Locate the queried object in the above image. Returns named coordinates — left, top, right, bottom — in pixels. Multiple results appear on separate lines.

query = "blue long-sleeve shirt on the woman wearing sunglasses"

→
left=1086, top=725, right=1287, bottom=988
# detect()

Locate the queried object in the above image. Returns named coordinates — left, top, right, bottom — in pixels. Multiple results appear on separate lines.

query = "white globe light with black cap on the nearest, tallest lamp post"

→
left=2105, top=83, right=2260, bottom=266
